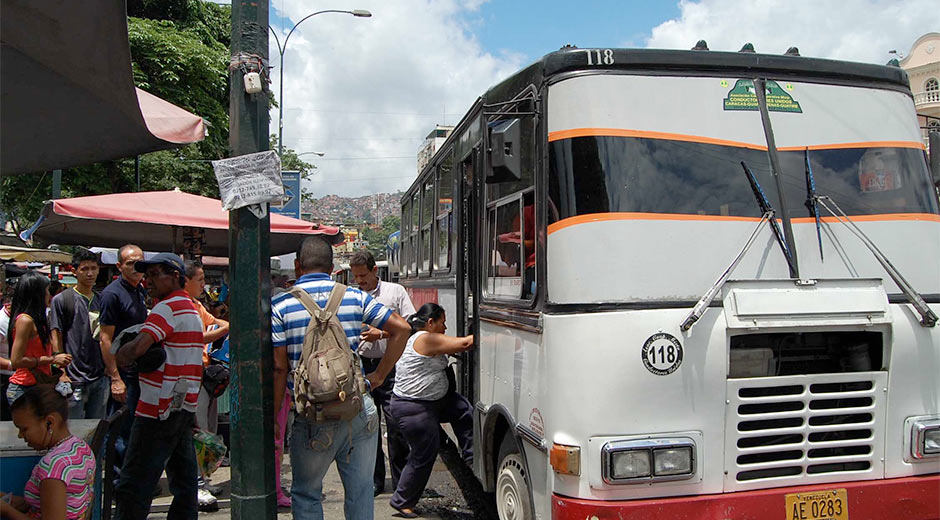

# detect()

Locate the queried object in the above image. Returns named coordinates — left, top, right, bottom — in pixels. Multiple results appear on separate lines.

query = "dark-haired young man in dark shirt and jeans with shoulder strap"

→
left=49, top=250, right=111, bottom=419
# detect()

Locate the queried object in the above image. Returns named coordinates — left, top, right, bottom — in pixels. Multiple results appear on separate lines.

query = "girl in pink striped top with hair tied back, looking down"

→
left=0, top=385, right=95, bottom=520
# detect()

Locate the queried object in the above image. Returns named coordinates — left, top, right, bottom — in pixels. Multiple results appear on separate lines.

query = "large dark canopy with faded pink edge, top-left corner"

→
left=0, top=0, right=205, bottom=175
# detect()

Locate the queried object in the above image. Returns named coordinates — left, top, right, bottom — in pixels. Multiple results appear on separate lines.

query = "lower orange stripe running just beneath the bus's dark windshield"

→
left=548, top=212, right=940, bottom=234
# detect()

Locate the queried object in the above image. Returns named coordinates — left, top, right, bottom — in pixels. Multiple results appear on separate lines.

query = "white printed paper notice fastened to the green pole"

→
left=212, top=150, right=284, bottom=211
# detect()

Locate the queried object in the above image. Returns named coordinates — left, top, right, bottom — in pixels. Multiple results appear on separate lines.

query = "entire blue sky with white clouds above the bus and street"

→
left=270, top=0, right=940, bottom=198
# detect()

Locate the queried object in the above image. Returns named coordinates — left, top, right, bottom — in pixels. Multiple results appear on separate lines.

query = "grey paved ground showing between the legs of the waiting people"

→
left=149, top=430, right=496, bottom=520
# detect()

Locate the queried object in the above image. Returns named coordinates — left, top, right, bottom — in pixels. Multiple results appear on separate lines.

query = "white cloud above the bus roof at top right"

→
left=646, top=0, right=940, bottom=64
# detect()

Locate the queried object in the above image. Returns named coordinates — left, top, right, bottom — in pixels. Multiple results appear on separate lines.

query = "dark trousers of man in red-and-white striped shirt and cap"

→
left=114, top=411, right=199, bottom=520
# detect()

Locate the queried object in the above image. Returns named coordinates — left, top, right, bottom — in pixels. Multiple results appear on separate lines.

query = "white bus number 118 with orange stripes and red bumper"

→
left=400, top=48, right=940, bottom=520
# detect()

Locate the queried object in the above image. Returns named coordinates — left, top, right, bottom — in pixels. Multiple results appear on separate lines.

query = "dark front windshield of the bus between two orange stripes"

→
left=549, top=136, right=938, bottom=219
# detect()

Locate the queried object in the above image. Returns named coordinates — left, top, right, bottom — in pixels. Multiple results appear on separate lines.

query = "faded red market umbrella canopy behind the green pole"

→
left=31, top=190, right=343, bottom=257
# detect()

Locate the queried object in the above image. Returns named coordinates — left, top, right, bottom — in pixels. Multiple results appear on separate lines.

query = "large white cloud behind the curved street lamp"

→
left=270, top=0, right=522, bottom=197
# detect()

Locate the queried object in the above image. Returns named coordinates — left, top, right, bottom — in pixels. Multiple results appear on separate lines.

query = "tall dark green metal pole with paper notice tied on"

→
left=229, top=0, right=277, bottom=520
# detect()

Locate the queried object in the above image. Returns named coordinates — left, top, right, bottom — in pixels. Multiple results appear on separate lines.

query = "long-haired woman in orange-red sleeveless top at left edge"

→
left=7, top=270, right=72, bottom=405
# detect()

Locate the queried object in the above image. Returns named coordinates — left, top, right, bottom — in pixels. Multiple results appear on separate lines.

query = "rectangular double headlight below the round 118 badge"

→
left=601, top=437, right=695, bottom=484
